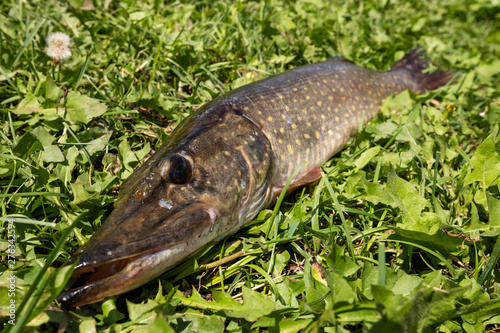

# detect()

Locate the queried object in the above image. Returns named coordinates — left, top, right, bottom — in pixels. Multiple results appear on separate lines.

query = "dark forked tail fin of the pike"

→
left=391, top=46, right=457, bottom=91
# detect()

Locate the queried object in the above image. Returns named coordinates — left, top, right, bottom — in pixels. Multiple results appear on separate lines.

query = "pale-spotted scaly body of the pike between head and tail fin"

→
left=220, top=58, right=422, bottom=187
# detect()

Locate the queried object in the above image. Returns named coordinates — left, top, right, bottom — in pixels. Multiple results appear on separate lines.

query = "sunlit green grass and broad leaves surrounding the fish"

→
left=0, top=0, right=500, bottom=332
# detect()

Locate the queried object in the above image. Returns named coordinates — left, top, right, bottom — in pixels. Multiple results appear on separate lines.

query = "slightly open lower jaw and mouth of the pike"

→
left=57, top=204, right=218, bottom=307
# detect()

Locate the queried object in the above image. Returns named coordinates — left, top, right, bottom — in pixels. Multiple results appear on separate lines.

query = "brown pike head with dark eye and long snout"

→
left=58, top=106, right=271, bottom=307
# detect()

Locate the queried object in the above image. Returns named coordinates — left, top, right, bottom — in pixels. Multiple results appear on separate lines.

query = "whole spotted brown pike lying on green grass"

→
left=58, top=48, right=453, bottom=307
